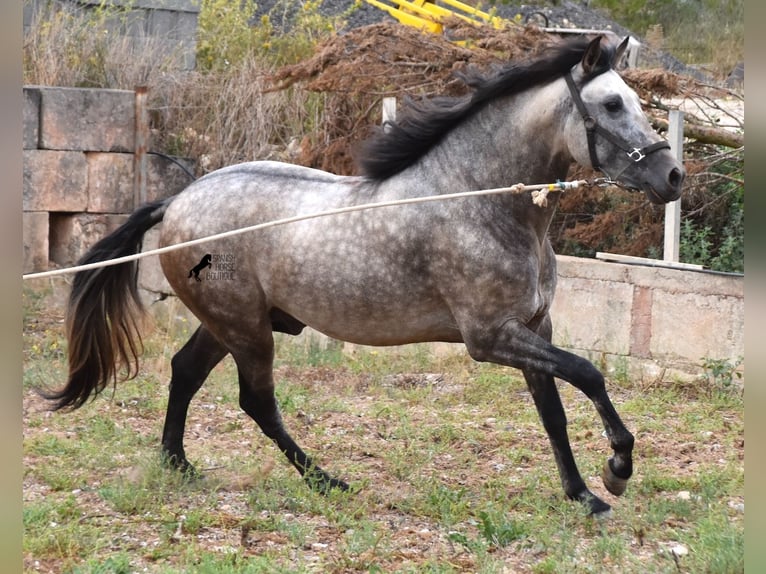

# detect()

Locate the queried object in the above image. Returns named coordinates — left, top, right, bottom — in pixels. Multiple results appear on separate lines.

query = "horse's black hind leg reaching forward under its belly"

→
left=232, top=338, right=348, bottom=493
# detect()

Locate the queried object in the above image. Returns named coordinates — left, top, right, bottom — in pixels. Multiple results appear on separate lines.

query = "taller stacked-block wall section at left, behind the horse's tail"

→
left=22, top=86, right=195, bottom=273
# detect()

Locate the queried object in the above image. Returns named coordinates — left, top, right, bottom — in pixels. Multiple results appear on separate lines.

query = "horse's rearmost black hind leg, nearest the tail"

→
left=162, top=325, right=228, bottom=474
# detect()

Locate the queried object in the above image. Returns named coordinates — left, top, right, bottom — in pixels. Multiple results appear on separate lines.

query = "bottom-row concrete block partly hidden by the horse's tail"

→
left=49, top=213, right=128, bottom=266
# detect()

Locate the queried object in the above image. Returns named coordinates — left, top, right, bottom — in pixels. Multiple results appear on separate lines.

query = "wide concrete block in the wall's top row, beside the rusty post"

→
left=40, top=88, right=135, bottom=152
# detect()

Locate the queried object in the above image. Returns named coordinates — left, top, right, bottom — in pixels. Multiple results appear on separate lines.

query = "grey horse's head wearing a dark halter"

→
left=565, top=37, right=686, bottom=203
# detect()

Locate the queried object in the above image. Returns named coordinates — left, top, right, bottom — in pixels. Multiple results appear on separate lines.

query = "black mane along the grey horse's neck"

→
left=358, top=38, right=614, bottom=181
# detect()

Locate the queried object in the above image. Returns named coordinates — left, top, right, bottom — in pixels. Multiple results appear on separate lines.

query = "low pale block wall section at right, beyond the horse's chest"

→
left=551, top=255, right=745, bottom=380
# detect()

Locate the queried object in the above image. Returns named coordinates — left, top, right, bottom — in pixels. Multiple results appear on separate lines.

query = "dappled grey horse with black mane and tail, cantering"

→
left=48, top=37, right=685, bottom=513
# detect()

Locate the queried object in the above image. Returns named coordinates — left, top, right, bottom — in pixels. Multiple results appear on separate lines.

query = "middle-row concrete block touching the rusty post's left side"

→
left=86, top=152, right=134, bottom=213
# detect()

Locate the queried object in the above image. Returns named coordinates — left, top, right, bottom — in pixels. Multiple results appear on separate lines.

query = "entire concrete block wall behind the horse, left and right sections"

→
left=23, top=87, right=745, bottom=380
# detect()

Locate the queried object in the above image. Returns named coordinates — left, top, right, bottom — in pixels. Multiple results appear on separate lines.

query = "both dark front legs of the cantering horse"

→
left=467, top=314, right=634, bottom=514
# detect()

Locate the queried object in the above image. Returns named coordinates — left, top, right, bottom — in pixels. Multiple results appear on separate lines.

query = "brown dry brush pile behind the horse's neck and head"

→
left=260, top=21, right=744, bottom=264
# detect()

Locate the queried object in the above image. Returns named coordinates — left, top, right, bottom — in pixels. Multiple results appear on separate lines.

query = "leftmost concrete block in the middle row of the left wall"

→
left=23, top=150, right=88, bottom=211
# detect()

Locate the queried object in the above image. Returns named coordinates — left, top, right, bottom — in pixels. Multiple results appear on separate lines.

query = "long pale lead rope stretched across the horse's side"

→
left=22, top=178, right=615, bottom=279
